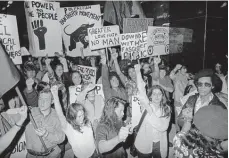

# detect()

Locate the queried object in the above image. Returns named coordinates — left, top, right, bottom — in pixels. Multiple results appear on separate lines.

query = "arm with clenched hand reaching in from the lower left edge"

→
left=0, top=106, right=27, bottom=155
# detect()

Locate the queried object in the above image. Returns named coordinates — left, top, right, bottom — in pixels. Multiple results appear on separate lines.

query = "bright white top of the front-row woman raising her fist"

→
left=63, top=122, right=95, bottom=158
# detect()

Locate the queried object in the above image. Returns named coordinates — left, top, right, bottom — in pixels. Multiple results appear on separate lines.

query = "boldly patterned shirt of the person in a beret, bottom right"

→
left=181, top=124, right=222, bottom=158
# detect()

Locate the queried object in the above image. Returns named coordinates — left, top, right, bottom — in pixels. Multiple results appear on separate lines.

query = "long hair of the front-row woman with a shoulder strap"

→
left=147, top=85, right=171, bottom=117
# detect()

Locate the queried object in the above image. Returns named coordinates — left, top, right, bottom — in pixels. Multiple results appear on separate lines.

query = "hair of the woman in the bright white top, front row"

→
left=66, top=103, right=89, bottom=132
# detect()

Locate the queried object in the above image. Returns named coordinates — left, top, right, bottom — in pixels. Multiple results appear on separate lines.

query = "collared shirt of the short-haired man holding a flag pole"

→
left=25, top=107, right=65, bottom=152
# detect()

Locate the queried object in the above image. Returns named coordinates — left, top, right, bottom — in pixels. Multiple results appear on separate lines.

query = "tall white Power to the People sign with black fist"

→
left=25, top=1, right=63, bottom=57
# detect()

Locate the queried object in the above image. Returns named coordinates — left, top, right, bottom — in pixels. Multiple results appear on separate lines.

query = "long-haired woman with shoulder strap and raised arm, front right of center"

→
left=134, top=64, right=171, bottom=158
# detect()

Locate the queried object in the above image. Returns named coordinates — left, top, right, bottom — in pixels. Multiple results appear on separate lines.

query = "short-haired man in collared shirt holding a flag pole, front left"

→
left=25, top=89, right=65, bottom=158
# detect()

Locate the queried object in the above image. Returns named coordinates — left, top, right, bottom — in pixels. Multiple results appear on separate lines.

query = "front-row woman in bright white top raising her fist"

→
left=51, top=85, right=96, bottom=158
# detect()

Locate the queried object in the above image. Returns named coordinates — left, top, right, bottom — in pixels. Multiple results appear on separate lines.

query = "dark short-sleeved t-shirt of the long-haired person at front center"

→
left=96, top=124, right=126, bottom=158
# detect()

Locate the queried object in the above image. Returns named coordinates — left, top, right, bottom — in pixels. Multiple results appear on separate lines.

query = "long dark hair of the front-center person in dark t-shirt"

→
left=100, top=97, right=126, bottom=131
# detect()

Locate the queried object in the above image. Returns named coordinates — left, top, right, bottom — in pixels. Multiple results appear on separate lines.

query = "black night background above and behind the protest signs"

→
left=0, top=1, right=228, bottom=72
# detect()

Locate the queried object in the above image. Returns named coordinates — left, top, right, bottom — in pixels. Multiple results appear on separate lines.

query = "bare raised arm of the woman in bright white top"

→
left=51, top=85, right=67, bottom=129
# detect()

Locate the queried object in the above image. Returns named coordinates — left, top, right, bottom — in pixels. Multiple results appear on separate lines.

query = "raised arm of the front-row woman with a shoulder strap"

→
left=134, top=64, right=152, bottom=115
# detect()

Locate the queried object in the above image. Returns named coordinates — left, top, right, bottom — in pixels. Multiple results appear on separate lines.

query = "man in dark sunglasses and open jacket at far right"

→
left=177, top=69, right=227, bottom=132
